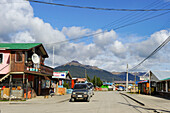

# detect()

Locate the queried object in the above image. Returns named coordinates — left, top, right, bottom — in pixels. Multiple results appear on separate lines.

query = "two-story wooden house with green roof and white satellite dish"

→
left=0, top=43, right=53, bottom=98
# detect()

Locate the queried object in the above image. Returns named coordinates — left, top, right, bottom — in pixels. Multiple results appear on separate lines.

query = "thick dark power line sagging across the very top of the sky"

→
left=27, top=0, right=170, bottom=11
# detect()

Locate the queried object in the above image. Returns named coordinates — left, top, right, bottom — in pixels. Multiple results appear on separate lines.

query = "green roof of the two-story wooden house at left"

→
left=0, top=43, right=41, bottom=49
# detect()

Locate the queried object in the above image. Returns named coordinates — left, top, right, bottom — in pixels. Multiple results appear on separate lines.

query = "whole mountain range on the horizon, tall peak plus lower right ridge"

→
left=54, top=61, right=145, bottom=82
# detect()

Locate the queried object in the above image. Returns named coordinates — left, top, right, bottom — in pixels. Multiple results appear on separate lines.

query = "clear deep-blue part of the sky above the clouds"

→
left=31, top=0, right=170, bottom=36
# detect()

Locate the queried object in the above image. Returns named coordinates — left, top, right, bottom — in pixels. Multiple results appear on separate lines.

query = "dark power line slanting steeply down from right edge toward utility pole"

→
left=130, top=36, right=170, bottom=71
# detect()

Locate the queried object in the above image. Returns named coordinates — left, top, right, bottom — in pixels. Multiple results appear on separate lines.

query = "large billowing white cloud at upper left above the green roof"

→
left=0, top=0, right=65, bottom=43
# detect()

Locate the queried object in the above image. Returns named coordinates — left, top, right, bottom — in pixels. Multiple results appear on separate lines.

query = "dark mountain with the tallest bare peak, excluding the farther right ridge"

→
left=54, top=61, right=121, bottom=82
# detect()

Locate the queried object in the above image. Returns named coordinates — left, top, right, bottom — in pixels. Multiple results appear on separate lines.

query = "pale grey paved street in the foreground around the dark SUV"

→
left=0, top=91, right=167, bottom=113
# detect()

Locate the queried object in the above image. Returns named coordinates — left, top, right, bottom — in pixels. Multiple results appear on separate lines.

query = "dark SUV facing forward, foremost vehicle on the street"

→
left=70, top=83, right=91, bottom=102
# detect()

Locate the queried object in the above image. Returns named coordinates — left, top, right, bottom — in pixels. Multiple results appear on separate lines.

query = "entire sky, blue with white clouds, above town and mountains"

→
left=0, top=0, right=170, bottom=72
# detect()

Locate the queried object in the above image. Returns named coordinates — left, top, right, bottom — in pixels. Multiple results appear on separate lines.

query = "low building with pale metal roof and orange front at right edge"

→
left=138, top=70, right=170, bottom=97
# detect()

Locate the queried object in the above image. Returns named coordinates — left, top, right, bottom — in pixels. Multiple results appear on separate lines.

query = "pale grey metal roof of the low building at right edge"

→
left=151, top=70, right=170, bottom=80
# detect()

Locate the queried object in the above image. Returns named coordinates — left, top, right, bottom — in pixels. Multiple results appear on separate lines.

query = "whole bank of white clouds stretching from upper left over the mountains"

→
left=0, top=0, right=170, bottom=71
